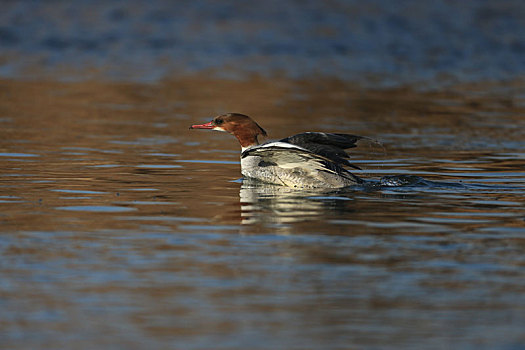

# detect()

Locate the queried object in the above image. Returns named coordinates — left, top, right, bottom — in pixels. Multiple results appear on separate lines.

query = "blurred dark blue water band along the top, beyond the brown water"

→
left=0, top=0, right=525, bottom=84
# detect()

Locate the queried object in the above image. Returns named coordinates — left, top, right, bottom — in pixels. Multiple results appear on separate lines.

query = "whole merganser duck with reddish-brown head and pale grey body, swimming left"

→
left=190, top=113, right=363, bottom=188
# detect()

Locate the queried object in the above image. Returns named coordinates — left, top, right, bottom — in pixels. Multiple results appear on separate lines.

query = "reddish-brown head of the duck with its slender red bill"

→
left=190, top=113, right=267, bottom=148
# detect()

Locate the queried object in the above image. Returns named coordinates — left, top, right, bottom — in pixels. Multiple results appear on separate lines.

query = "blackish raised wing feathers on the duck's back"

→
left=281, top=132, right=363, bottom=169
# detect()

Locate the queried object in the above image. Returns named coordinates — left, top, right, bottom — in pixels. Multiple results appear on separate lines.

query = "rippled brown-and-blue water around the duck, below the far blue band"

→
left=0, top=77, right=525, bottom=349
